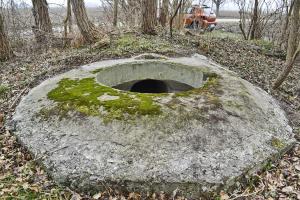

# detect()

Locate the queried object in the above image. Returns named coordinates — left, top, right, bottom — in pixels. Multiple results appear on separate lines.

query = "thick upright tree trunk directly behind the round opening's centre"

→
left=142, top=0, right=157, bottom=35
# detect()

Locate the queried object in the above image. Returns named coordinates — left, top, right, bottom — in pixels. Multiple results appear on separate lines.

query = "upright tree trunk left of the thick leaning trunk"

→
left=32, top=0, right=53, bottom=43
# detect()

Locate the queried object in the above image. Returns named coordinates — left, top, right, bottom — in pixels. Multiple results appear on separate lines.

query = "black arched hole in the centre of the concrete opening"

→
left=130, top=79, right=169, bottom=93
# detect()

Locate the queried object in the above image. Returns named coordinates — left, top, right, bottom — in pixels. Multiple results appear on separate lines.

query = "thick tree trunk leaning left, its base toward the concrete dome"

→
left=71, top=0, right=104, bottom=43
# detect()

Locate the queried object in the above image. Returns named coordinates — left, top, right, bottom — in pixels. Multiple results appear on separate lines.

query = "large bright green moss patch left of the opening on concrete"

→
left=45, top=78, right=161, bottom=120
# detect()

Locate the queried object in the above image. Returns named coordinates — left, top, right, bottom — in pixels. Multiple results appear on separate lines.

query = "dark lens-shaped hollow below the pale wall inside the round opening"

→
left=113, top=79, right=193, bottom=93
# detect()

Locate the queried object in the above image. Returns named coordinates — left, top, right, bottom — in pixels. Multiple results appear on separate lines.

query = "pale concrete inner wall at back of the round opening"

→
left=96, top=61, right=206, bottom=88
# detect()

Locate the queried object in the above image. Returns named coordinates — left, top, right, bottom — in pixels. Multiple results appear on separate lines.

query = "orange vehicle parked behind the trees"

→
left=184, top=5, right=217, bottom=31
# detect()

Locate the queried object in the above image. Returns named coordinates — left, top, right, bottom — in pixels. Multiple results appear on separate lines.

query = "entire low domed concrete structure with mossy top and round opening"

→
left=14, top=55, right=295, bottom=198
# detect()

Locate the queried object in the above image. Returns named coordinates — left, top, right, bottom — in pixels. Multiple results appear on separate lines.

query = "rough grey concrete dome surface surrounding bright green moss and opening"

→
left=14, top=55, right=294, bottom=197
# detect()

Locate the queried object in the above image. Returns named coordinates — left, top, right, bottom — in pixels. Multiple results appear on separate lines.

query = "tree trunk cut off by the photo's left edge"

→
left=0, top=10, right=13, bottom=61
